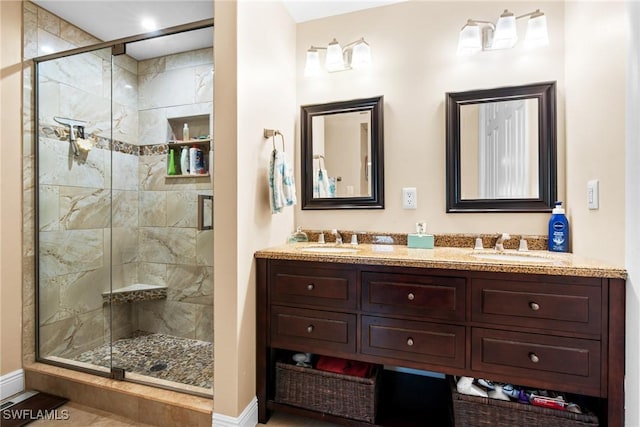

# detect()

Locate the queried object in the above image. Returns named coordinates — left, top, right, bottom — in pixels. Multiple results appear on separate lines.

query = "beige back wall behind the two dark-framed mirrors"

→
left=296, top=1, right=565, bottom=235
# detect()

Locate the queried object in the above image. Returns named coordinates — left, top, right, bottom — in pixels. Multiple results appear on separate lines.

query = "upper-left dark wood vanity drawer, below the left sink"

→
left=270, top=263, right=357, bottom=308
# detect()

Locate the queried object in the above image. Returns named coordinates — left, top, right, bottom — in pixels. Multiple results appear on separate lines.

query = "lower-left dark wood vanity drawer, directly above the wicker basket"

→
left=271, top=305, right=356, bottom=352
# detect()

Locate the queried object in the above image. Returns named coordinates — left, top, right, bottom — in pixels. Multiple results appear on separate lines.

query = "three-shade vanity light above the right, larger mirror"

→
left=458, top=9, right=549, bottom=55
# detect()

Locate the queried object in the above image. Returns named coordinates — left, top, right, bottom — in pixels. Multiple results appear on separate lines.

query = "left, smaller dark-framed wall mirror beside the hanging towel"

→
left=300, top=96, right=384, bottom=209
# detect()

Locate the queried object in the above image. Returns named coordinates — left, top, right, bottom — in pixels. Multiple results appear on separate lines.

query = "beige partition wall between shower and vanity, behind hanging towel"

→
left=214, top=1, right=296, bottom=418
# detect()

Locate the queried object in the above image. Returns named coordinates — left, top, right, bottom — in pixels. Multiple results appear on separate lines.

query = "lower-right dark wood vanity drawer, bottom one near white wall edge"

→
left=471, top=328, right=600, bottom=395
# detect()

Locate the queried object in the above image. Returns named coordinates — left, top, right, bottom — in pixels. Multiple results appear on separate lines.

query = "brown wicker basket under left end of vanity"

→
left=275, top=362, right=380, bottom=423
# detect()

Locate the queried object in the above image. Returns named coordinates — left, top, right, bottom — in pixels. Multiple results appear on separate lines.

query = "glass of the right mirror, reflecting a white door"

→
left=460, top=98, right=539, bottom=200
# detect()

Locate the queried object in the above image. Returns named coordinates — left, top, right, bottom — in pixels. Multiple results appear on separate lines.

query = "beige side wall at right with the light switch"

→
left=559, top=2, right=628, bottom=265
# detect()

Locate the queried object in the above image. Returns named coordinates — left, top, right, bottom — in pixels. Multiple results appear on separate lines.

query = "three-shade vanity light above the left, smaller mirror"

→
left=304, top=38, right=371, bottom=76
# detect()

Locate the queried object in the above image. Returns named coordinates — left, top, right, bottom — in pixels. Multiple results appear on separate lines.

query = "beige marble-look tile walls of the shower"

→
left=23, top=2, right=213, bottom=362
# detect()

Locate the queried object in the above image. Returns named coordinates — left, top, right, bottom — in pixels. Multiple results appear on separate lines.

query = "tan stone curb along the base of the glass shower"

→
left=24, top=363, right=213, bottom=427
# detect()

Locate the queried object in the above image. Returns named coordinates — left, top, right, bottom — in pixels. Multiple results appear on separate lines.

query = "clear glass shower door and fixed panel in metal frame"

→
left=34, top=16, right=213, bottom=396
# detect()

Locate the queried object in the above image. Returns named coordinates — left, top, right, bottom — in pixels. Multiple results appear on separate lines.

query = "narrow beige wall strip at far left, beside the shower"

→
left=0, top=1, right=22, bottom=375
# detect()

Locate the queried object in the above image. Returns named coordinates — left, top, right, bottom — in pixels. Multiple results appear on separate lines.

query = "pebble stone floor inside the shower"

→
left=73, top=333, right=213, bottom=389
